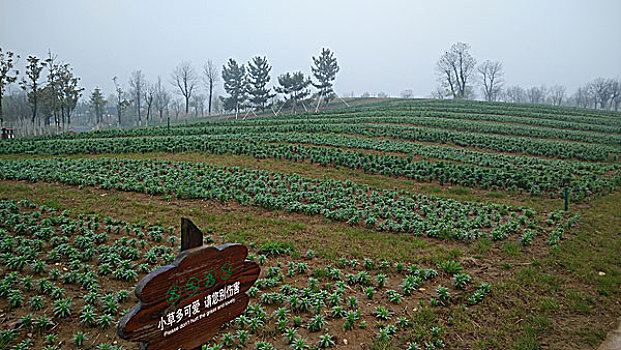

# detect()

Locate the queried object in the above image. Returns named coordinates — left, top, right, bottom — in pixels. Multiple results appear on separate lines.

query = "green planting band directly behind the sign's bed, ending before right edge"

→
left=0, top=158, right=548, bottom=241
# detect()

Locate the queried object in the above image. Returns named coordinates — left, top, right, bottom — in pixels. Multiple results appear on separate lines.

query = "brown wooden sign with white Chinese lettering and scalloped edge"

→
left=118, top=219, right=260, bottom=350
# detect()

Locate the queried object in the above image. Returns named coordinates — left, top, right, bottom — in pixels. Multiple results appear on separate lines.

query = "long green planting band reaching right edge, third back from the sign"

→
left=1, top=133, right=621, bottom=200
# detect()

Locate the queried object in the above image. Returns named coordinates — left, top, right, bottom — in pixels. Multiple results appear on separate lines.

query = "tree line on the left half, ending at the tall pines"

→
left=0, top=48, right=340, bottom=134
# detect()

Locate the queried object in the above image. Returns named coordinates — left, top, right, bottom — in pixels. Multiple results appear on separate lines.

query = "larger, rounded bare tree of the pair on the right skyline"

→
left=437, top=42, right=476, bottom=99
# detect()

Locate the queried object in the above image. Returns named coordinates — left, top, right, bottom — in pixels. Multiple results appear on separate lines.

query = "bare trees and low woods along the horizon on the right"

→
left=432, top=42, right=621, bottom=111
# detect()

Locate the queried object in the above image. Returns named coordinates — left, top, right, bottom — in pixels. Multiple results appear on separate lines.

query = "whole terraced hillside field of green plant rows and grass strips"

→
left=0, top=100, right=621, bottom=349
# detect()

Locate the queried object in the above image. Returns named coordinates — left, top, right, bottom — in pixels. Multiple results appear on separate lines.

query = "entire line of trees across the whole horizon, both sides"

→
left=0, top=42, right=621, bottom=134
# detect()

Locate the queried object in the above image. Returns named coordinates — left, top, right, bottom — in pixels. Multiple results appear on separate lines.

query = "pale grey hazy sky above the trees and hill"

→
left=0, top=0, right=621, bottom=96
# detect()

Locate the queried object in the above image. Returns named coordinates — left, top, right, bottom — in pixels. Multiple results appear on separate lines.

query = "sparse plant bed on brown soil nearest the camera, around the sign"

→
left=0, top=200, right=491, bottom=350
